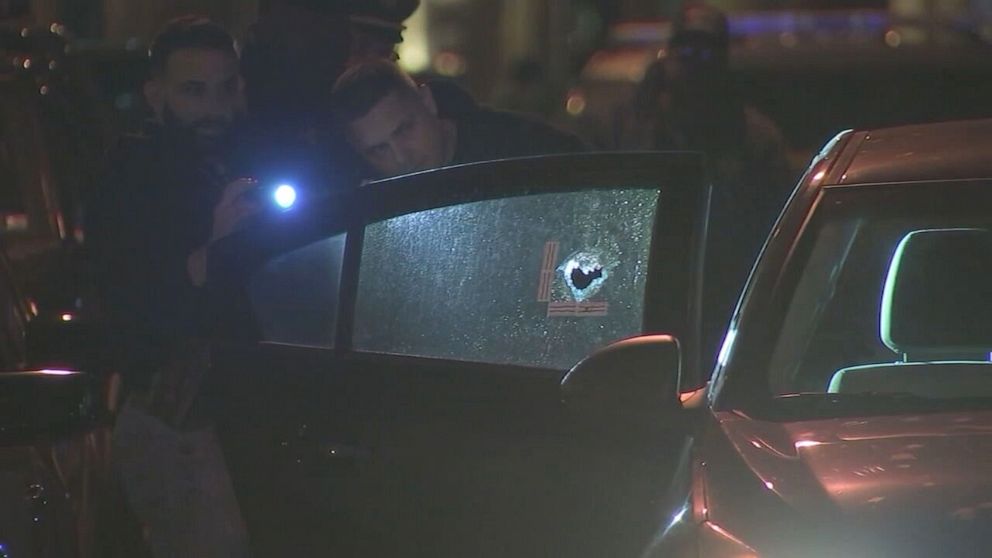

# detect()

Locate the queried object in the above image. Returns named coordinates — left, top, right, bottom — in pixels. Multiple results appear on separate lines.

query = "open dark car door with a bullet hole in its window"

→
left=205, top=153, right=708, bottom=556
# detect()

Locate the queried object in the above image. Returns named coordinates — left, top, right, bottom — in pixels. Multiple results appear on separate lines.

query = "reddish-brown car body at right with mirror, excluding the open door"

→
left=563, top=120, right=992, bottom=557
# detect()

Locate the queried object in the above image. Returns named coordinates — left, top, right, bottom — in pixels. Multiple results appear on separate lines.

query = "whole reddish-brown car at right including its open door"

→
left=207, top=121, right=992, bottom=557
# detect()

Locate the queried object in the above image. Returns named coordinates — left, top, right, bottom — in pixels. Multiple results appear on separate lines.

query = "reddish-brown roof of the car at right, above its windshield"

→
left=824, top=118, right=992, bottom=186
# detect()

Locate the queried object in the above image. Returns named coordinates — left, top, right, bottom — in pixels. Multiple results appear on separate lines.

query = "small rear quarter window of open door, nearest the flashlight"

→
left=248, top=234, right=345, bottom=348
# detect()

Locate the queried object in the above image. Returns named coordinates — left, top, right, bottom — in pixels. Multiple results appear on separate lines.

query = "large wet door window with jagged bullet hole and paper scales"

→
left=354, top=188, right=659, bottom=369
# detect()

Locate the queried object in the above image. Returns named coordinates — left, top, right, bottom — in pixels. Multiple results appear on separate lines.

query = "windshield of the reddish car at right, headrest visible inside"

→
left=761, top=182, right=992, bottom=415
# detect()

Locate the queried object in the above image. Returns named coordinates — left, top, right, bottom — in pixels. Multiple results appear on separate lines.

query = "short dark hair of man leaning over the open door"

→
left=331, top=60, right=417, bottom=125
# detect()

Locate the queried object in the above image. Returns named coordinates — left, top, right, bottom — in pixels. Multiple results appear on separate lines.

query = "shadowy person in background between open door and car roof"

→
left=617, top=4, right=794, bottom=372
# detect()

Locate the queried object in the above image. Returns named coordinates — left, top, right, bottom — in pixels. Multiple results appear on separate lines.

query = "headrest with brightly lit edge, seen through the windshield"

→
left=881, top=229, right=992, bottom=357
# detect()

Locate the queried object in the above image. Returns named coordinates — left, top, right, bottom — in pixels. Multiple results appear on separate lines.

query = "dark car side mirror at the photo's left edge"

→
left=0, top=370, right=102, bottom=445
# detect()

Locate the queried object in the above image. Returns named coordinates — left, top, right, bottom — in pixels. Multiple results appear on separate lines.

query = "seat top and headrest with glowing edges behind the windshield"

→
left=829, top=229, right=992, bottom=397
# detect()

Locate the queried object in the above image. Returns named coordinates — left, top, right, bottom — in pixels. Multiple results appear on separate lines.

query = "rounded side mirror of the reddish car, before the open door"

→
left=561, top=335, right=682, bottom=422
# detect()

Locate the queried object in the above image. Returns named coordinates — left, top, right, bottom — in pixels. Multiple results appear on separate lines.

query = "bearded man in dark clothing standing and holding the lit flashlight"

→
left=86, top=17, right=255, bottom=556
